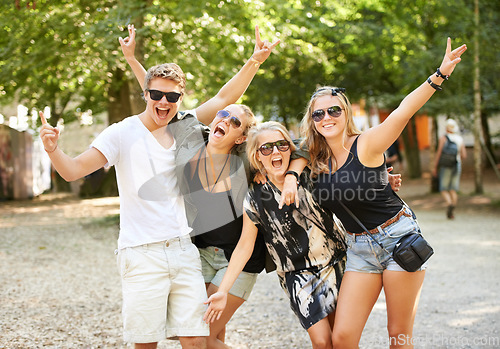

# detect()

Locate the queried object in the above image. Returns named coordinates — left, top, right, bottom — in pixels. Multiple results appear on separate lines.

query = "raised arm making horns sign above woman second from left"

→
left=196, top=26, right=280, bottom=125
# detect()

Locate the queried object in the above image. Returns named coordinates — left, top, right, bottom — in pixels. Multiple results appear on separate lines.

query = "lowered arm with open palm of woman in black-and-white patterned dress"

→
left=203, top=213, right=258, bottom=323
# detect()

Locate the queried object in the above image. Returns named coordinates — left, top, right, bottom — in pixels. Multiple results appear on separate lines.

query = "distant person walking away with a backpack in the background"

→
left=432, top=119, right=467, bottom=219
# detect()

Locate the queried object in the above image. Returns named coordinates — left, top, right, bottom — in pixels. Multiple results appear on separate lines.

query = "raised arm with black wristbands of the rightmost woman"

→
left=358, top=38, right=467, bottom=162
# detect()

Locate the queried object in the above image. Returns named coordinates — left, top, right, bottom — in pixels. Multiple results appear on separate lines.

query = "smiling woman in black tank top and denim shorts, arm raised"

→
left=302, top=38, right=467, bottom=349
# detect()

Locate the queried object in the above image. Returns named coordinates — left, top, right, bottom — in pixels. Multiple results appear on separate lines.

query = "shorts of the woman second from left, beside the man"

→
left=198, top=246, right=258, bottom=300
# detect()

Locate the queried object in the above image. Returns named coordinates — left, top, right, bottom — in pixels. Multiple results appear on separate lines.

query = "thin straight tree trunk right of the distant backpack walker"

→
left=474, top=0, right=483, bottom=194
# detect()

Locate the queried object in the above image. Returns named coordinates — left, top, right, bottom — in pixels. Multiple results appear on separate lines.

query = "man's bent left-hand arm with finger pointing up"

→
left=40, top=112, right=107, bottom=182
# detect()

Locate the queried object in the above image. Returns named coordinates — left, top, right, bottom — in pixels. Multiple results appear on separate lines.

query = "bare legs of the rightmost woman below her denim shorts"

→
left=332, top=270, right=425, bottom=349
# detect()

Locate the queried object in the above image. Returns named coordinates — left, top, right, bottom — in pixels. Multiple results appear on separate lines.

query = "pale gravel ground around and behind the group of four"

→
left=0, top=169, right=500, bottom=349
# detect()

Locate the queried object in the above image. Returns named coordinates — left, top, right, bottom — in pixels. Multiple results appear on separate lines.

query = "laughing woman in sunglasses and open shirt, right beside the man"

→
left=184, top=104, right=265, bottom=347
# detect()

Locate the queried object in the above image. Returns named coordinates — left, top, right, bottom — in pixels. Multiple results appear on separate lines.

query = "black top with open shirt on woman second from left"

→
left=184, top=157, right=265, bottom=273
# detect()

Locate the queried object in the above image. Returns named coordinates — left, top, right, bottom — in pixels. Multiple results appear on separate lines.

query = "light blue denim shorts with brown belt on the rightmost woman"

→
left=346, top=206, right=427, bottom=274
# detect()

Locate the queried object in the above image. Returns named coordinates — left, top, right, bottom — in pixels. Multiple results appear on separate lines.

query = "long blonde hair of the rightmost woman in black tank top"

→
left=300, top=86, right=361, bottom=177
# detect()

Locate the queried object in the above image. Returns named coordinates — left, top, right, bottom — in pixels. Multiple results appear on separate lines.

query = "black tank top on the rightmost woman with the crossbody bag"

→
left=313, top=137, right=403, bottom=233
